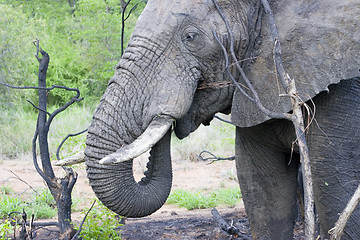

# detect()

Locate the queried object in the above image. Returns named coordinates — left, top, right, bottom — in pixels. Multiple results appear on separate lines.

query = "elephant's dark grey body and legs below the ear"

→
left=236, top=78, right=360, bottom=239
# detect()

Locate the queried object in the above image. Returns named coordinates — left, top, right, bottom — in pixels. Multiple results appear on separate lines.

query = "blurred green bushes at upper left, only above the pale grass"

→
left=0, top=0, right=146, bottom=109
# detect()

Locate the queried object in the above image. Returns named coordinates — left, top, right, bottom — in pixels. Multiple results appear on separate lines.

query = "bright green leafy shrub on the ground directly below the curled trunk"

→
left=76, top=203, right=122, bottom=240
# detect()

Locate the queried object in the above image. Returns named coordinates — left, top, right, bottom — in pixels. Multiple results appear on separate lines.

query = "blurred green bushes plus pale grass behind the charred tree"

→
left=0, top=0, right=146, bottom=158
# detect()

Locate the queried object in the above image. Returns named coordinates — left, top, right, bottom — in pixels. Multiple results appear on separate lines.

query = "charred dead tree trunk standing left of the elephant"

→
left=33, top=40, right=82, bottom=240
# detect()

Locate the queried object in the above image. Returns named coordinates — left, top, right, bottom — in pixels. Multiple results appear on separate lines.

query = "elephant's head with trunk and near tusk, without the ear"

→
left=85, top=0, right=255, bottom=217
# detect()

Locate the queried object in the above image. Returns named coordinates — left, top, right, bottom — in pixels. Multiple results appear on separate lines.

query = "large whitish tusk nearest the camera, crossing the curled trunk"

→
left=99, top=115, right=174, bottom=164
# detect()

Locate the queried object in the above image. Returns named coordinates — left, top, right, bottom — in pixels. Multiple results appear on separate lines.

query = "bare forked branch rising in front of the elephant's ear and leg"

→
left=213, top=0, right=315, bottom=239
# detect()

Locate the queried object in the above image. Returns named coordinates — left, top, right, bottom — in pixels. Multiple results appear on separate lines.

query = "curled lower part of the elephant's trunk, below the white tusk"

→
left=86, top=131, right=172, bottom=217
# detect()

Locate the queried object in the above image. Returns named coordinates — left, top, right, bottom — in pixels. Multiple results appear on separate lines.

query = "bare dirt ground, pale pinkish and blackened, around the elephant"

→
left=0, top=159, right=303, bottom=240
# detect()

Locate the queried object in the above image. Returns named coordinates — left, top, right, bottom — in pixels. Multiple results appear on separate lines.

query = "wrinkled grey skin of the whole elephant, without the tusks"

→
left=85, top=0, right=360, bottom=239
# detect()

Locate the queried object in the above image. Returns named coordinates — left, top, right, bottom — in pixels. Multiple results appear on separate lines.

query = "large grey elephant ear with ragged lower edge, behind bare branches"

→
left=232, top=0, right=360, bottom=127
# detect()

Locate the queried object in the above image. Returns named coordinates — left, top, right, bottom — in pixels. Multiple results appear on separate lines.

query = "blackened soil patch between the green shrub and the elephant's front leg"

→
left=121, top=209, right=251, bottom=240
